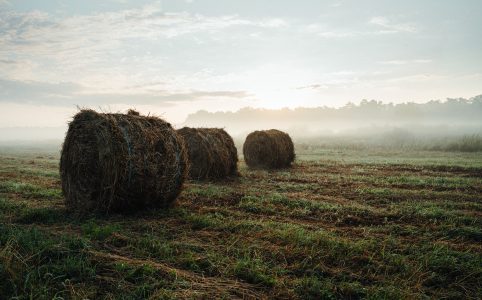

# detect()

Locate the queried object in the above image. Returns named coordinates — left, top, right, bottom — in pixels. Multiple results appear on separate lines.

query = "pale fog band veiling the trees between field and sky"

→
left=0, top=95, right=482, bottom=151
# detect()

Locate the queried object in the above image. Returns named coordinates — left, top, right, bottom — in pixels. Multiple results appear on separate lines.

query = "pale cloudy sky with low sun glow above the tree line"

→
left=0, top=0, right=482, bottom=127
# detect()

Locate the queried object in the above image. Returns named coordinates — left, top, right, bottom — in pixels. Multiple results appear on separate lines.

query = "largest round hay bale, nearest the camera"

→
left=60, top=110, right=188, bottom=213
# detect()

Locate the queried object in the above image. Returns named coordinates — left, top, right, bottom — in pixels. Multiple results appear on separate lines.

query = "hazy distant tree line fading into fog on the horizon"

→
left=186, top=95, right=482, bottom=130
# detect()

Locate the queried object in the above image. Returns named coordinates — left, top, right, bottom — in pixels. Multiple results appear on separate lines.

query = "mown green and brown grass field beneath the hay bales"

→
left=0, top=149, right=482, bottom=299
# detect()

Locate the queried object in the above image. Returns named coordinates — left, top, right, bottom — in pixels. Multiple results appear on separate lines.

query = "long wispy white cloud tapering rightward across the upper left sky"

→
left=0, top=5, right=288, bottom=55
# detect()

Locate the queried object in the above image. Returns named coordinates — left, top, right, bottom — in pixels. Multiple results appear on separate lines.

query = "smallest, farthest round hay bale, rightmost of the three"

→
left=243, top=129, right=295, bottom=169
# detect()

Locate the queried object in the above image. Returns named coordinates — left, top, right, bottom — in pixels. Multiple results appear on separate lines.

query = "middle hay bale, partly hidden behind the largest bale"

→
left=177, top=127, right=238, bottom=180
